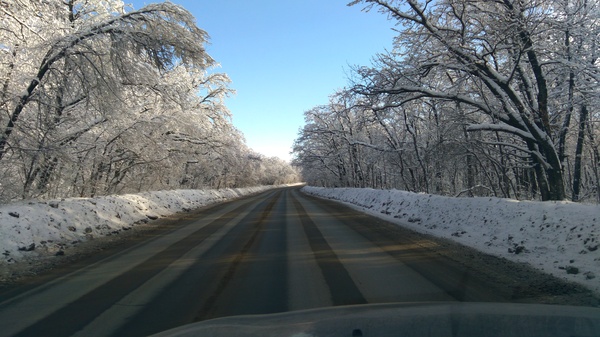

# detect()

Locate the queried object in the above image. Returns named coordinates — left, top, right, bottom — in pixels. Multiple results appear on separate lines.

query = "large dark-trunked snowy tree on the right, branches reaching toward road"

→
left=352, top=0, right=597, bottom=200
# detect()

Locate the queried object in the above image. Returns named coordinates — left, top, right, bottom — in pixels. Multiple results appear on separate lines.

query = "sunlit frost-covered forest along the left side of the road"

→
left=0, top=0, right=299, bottom=202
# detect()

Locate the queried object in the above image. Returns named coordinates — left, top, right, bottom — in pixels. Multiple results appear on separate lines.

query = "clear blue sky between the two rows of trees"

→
left=125, top=0, right=395, bottom=160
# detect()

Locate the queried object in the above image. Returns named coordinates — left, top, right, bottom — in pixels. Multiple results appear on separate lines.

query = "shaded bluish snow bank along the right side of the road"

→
left=302, top=186, right=600, bottom=293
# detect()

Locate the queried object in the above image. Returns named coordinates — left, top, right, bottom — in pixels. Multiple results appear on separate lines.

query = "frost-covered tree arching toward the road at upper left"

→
left=0, top=0, right=213, bottom=159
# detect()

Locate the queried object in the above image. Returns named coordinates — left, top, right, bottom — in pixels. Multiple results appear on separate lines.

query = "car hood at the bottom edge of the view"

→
left=155, top=303, right=600, bottom=337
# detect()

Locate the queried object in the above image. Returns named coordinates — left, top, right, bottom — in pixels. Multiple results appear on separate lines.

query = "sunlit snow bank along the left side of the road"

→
left=0, top=186, right=274, bottom=268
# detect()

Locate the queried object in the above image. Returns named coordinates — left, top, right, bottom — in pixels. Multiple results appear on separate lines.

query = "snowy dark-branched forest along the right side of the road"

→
left=294, top=0, right=600, bottom=203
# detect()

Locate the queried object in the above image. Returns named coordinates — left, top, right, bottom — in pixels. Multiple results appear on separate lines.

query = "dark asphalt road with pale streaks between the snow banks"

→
left=0, top=188, right=552, bottom=336
